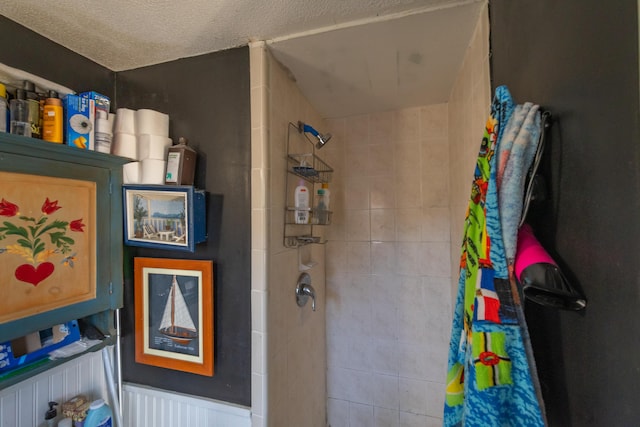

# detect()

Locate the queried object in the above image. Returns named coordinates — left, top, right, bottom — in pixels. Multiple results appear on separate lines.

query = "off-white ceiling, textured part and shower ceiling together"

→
left=0, top=0, right=486, bottom=117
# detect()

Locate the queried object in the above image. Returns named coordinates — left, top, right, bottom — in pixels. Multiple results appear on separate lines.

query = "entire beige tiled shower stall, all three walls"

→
left=251, top=7, right=491, bottom=427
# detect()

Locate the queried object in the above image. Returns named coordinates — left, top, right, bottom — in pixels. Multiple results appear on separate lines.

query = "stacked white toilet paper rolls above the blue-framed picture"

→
left=112, top=108, right=172, bottom=184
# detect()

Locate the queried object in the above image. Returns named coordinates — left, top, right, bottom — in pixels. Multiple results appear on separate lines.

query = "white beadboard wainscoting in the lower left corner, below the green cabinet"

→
left=0, top=351, right=108, bottom=427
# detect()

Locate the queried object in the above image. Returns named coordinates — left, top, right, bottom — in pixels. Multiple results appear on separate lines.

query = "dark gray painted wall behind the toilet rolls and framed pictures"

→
left=0, top=17, right=251, bottom=406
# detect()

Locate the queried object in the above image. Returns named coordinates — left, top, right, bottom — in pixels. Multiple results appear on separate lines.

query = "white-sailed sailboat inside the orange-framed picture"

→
left=159, top=275, right=198, bottom=345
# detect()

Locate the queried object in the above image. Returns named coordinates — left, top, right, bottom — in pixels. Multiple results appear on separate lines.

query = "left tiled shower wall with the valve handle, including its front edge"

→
left=251, top=43, right=333, bottom=427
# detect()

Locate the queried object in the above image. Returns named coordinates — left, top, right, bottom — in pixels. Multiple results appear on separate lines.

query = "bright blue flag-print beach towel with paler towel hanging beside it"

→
left=443, top=86, right=545, bottom=427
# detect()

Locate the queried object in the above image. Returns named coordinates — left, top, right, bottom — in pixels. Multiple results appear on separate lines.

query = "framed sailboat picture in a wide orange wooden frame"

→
left=134, top=258, right=213, bottom=376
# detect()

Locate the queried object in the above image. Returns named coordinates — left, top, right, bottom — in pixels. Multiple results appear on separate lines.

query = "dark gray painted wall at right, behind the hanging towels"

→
left=490, top=0, right=640, bottom=427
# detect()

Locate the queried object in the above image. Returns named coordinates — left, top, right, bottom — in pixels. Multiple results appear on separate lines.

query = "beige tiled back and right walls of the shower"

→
left=323, top=4, right=490, bottom=427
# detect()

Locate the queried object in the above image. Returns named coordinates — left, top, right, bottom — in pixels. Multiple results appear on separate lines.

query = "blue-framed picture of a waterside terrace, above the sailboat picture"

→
left=122, top=185, right=206, bottom=252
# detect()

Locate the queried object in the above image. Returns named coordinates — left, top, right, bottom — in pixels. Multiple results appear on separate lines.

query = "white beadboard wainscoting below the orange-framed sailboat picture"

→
left=122, top=383, right=251, bottom=427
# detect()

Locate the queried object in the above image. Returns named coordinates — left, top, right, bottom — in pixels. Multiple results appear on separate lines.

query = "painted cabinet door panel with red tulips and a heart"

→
left=0, top=171, right=97, bottom=323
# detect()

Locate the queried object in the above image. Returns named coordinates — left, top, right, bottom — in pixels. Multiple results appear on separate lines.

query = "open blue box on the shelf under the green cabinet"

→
left=0, top=320, right=80, bottom=374
